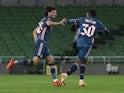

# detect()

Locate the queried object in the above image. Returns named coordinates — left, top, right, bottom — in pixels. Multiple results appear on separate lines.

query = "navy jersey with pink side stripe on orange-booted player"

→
left=36, top=17, right=51, bottom=44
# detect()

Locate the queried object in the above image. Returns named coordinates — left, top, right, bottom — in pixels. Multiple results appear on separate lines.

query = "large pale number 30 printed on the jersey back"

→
left=81, top=24, right=96, bottom=37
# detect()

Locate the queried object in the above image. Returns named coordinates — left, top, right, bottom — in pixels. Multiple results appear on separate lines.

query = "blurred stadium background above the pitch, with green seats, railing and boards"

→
left=0, top=0, right=124, bottom=74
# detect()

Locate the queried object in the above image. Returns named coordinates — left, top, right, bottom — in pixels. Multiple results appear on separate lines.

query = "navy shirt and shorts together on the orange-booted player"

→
left=33, top=17, right=51, bottom=58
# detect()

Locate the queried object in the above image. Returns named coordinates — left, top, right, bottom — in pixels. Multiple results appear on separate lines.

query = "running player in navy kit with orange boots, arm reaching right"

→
left=7, top=6, right=66, bottom=86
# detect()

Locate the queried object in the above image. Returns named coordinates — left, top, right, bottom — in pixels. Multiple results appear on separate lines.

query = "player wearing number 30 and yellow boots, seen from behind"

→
left=61, top=9, right=109, bottom=86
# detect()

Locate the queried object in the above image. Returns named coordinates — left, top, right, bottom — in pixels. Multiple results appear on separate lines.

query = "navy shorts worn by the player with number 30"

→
left=77, top=47, right=92, bottom=61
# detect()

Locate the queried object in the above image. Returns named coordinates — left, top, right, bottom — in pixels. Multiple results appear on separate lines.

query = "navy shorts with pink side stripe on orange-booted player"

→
left=33, top=42, right=51, bottom=59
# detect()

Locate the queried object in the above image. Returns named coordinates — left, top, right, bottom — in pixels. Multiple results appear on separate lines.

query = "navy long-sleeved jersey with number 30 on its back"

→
left=68, top=17, right=108, bottom=47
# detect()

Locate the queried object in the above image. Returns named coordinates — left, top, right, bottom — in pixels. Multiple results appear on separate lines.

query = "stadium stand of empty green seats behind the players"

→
left=0, top=6, right=124, bottom=58
